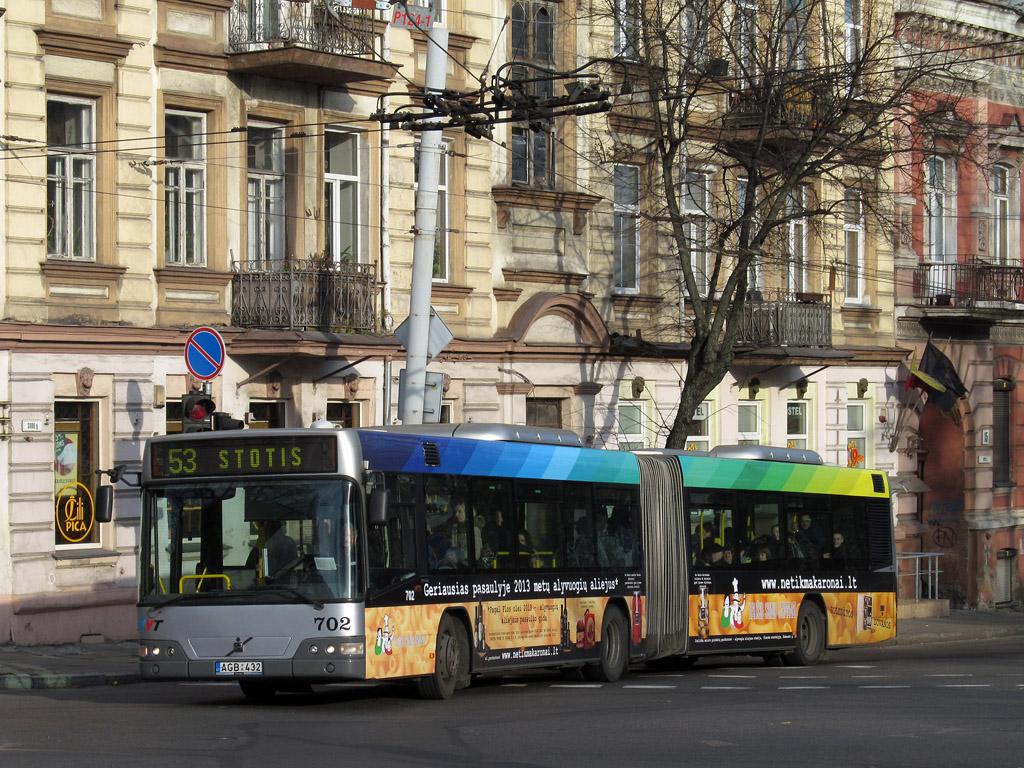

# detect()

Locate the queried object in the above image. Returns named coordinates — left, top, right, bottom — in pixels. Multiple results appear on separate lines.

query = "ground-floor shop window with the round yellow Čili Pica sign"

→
left=53, top=402, right=99, bottom=547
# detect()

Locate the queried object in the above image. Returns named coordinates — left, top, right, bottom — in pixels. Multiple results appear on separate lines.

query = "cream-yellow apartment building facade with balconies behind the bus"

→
left=0, top=0, right=929, bottom=644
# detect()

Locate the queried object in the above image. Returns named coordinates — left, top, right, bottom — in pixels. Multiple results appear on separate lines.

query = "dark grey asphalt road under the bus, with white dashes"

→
left=0, top=637, right=1024, bottom=768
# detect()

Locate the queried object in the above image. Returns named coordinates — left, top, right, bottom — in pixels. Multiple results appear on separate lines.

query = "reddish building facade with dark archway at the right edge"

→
left=891, top=0, right=1024, bottom=608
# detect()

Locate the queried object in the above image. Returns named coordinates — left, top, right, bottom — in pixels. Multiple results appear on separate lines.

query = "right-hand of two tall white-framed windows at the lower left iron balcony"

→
left=324, top=125, right=366, bottom=264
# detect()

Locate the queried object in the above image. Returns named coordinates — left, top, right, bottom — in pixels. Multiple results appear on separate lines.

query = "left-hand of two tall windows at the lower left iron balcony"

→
left=246, top=122, right=288, bottom=269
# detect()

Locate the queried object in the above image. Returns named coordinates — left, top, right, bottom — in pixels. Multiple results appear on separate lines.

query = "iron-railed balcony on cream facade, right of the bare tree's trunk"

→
left=736, top=291, right=833, bottom=347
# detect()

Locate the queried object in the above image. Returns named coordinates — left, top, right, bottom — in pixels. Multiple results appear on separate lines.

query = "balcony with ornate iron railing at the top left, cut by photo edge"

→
left=228, top=0, right=395, bottom=86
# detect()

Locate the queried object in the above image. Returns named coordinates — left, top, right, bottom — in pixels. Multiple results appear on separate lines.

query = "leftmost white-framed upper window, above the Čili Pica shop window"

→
left=46, top=94, right=96, bottom=261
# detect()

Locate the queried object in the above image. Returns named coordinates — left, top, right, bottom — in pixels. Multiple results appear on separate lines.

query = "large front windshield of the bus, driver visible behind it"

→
left=139, top=478, right=362, bottom=604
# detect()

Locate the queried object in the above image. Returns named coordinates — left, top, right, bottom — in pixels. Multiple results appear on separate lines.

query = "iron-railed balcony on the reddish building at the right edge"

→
left=913, top=259, right=1024, bottom=307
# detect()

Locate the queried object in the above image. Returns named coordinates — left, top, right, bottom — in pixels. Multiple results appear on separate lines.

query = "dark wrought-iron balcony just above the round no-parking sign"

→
left=231, top=258, right=379, bottom=334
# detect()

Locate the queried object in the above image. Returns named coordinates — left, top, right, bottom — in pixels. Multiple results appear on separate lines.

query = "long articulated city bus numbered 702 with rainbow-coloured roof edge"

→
left=138, top=424, right=896, bottom=698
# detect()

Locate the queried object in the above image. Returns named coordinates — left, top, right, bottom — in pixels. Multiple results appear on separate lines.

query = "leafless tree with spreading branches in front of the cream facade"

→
left=592, top=0, right=971, bottom=447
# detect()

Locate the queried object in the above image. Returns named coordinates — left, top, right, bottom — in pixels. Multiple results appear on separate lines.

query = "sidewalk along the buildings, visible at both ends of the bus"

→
left=0, top=610, right=1024, bottom=690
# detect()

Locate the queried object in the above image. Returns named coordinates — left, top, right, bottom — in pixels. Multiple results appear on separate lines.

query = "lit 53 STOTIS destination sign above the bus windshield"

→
left=152, top=430, right=338, bottom=478
